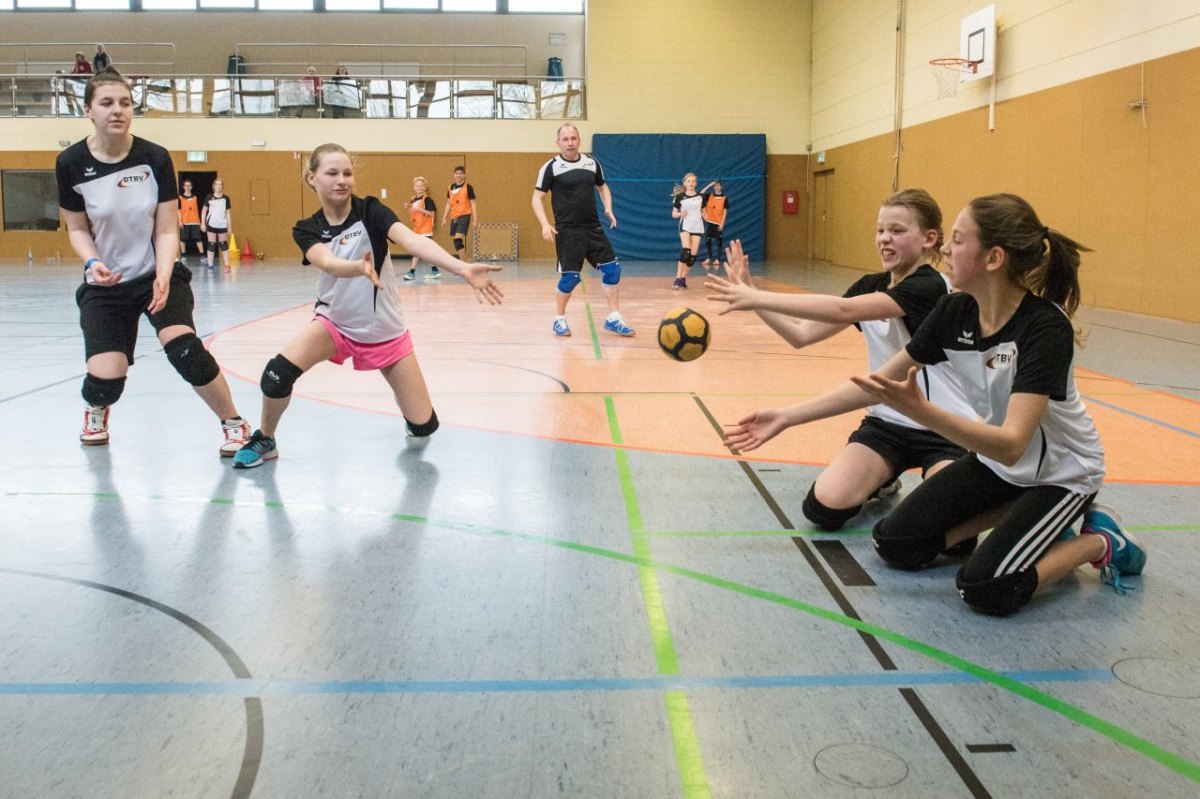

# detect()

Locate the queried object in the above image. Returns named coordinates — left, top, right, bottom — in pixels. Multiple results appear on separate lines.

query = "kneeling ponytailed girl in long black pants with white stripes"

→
left=730, top=194, right=1146, bottom=614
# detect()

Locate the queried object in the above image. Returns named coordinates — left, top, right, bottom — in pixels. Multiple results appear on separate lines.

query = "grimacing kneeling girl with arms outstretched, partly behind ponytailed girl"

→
left=704, top=188, right=974, bottom=535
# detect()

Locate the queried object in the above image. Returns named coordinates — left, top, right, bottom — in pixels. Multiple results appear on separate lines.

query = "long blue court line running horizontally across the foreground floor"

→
left=0, top=668, right=1116, bottom=697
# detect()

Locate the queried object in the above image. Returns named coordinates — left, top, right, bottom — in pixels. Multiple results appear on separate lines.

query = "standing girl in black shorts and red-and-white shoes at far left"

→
left=55, top=68, right=250, bottom=457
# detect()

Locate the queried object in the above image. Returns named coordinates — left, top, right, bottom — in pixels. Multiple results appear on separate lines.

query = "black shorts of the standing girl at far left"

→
left=76, top=263, right=196, bottom=366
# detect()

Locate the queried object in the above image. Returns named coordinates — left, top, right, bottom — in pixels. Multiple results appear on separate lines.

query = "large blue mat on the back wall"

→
left=592, top=133, right=767, bottom=262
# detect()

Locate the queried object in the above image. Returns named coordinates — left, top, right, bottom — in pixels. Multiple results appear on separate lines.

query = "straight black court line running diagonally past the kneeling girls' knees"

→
left=692, top=395, right=991, bottom=799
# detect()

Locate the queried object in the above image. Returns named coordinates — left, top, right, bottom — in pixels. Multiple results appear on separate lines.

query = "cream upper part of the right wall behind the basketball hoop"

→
left=811, top=0, right=1200, bottom=150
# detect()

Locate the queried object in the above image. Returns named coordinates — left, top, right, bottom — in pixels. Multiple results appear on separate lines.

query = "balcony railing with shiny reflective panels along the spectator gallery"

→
left=0, top=73, right=587, bottom=120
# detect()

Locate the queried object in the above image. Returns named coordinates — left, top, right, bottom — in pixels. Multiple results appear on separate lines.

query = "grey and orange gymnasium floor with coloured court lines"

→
left=0, top=256, right=1200, bottom=799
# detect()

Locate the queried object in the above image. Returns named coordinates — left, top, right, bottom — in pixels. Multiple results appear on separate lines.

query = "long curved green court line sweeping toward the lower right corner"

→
left=5, top=492, right=1200, bottom=783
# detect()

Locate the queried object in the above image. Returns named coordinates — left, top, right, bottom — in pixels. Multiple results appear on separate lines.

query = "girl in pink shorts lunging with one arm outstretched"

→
left=233, top=144, right=504, bottom=469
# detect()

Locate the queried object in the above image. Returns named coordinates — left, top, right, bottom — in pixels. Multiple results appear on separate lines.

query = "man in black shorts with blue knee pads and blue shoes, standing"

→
left=533, top=122, right=634, bottom=336
